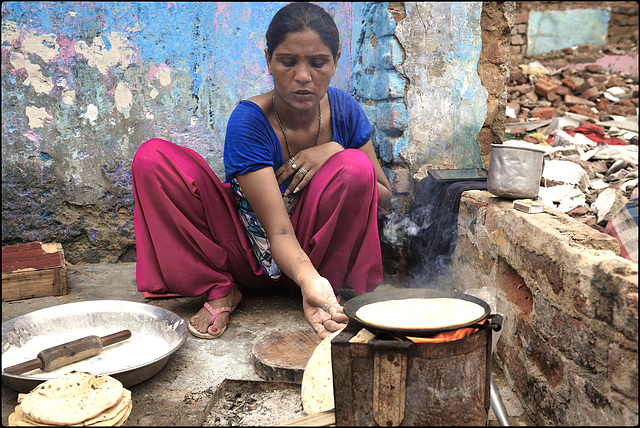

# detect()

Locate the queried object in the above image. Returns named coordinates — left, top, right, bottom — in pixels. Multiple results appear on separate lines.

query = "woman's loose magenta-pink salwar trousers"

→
left=131, top=139, right=382, bottom=300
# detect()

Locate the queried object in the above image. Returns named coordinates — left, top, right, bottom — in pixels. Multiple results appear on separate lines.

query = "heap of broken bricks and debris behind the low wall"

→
left=505, top=55, right=638, bottom=262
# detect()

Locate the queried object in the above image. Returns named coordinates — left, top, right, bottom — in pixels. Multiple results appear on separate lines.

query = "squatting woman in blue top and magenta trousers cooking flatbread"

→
left=132, top=3, right=391, bottom=338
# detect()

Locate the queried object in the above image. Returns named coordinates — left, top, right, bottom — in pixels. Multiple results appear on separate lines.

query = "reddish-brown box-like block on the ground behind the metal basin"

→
left=2, top=242, right=67, bottom=302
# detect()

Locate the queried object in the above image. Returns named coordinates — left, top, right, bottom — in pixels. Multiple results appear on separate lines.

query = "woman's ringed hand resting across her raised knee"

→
left=276, top=141, right=344, bottom=195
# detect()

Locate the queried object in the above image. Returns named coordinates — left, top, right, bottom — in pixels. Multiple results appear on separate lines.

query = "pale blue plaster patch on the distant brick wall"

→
left=527, top=9, right=611, bottom=56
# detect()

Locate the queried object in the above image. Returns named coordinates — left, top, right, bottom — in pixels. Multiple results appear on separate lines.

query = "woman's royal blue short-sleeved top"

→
left=224, top=87, right=373, bottom=193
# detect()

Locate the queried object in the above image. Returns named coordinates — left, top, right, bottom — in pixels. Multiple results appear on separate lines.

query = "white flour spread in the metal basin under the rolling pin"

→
left=2, top=328, right=171, bottom=378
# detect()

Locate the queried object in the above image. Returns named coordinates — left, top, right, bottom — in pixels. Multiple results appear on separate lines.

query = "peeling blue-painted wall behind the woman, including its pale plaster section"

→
left=2, top=2, right=486, bottom=263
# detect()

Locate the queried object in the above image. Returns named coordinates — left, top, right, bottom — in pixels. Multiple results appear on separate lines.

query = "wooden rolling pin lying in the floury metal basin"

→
left=4, top=330, right=131, bottom=375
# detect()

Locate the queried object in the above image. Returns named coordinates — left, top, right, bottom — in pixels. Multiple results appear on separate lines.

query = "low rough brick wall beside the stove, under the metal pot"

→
left=451, top=191, right=638, bottom=426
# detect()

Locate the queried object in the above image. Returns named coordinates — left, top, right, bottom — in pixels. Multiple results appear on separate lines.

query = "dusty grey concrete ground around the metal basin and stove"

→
left=2, top=263, right=533, bottom=426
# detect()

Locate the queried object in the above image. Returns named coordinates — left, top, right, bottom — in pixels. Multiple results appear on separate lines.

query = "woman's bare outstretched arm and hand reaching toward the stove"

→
left=237, top=167, right=347, bottom=338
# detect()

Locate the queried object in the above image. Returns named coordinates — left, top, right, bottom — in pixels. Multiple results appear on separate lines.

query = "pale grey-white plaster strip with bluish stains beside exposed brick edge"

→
left=396, top=2, right=487, bottom=172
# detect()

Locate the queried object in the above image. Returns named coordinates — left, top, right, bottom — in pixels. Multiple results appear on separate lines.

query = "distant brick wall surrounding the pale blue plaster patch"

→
left=510, top=1, right=638, bottom=65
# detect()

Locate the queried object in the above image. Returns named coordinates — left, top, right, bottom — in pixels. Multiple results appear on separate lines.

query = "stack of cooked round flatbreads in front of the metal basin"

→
left=9, top=371, right=132, bottom=426
